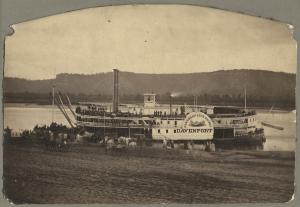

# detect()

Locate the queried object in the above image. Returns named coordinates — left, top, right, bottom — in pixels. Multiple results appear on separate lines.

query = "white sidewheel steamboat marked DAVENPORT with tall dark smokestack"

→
left=69, top=69, right=266, bottom=148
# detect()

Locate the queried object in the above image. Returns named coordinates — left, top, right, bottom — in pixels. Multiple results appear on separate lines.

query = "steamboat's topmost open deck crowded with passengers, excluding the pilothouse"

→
left=75, top=103, right=256, bottom=119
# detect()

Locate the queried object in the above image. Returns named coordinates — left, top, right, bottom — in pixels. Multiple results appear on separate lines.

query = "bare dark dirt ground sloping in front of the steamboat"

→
left=3, top=144, right=294, bottom=204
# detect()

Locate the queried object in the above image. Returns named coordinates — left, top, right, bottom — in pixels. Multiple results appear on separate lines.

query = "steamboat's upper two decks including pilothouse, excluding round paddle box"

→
left=75, top=93, right=256, bottom=131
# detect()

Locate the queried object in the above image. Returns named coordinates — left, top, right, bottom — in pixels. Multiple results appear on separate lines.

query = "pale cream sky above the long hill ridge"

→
left=4, top=5, right=297, bottom=80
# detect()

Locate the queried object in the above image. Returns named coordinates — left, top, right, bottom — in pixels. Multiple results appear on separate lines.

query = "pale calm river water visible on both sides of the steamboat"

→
left=4, top=104, right=296, bottom=151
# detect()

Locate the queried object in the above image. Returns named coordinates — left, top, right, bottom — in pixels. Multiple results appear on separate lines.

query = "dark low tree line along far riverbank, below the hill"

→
left=4, top=92, right=295, bottom=109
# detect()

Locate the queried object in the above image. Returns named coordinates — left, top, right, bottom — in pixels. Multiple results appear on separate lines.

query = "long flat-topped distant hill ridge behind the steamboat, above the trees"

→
left=4, top=70, right=296, bottom=107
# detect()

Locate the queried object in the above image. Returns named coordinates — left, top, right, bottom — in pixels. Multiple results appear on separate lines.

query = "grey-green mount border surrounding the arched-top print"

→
left=0, top=0, right=300, bottom=206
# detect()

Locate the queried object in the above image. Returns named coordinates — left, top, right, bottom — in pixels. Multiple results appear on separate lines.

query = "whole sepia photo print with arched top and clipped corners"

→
left=3, top=5, right=297, bottom=204
